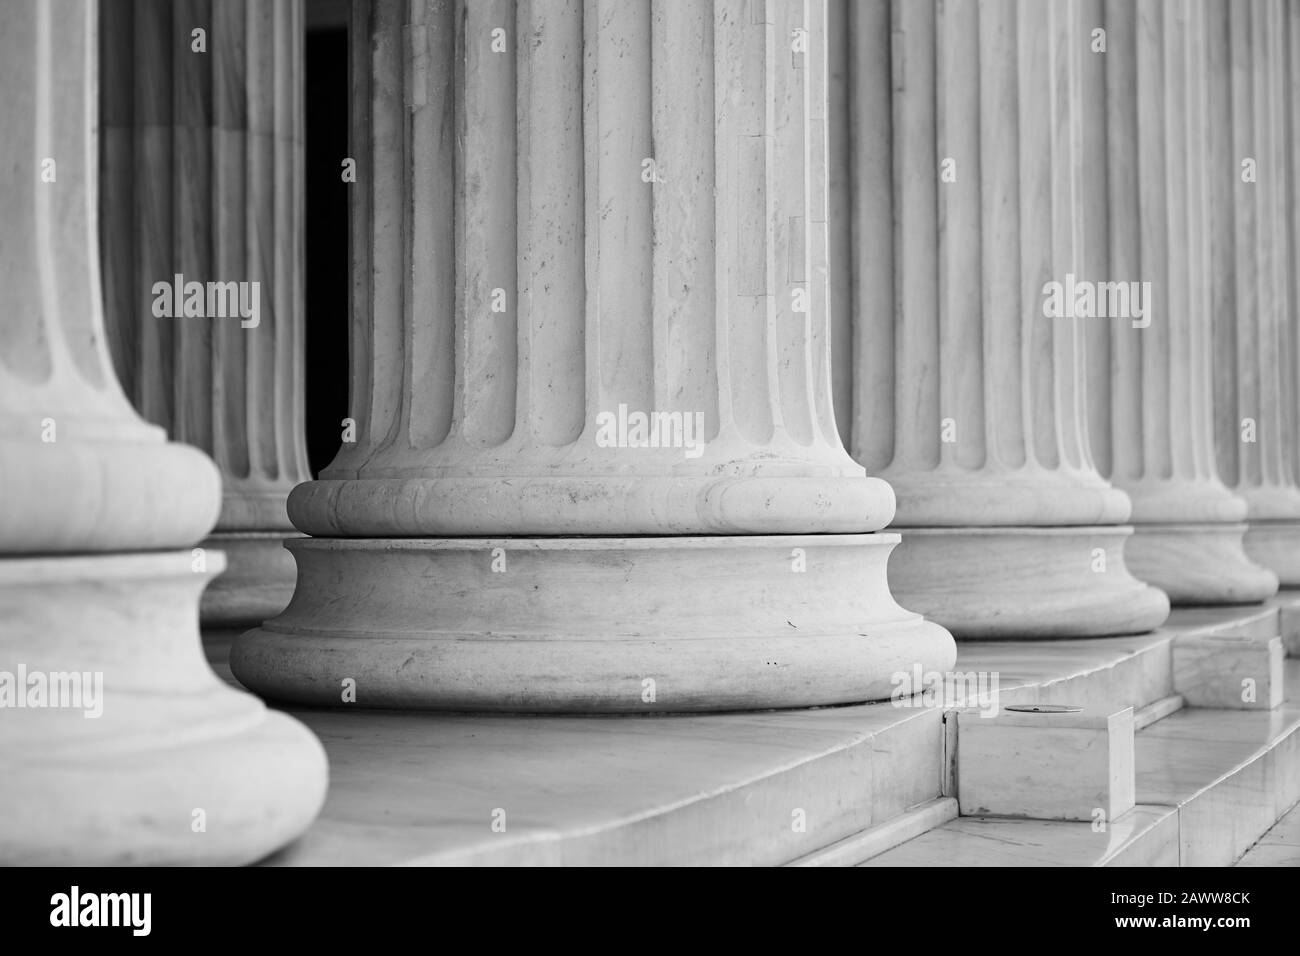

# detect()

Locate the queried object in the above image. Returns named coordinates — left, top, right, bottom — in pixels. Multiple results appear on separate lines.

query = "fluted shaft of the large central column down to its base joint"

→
left=290, top=3, right=893, bottom=535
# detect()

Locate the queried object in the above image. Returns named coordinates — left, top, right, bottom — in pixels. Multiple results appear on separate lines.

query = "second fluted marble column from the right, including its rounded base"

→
left=1080, top=0, right=1278, bottom=605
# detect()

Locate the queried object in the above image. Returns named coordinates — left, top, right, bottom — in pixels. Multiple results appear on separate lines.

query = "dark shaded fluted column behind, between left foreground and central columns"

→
left=100, top=0, right=311, bottom=626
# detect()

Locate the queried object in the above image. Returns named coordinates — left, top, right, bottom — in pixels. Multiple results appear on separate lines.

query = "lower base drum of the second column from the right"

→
left=1125, top=524, right=1278, bottom=605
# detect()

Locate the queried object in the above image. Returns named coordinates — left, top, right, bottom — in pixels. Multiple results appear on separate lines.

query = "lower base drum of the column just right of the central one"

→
left=889, top=525, right=1169, bottom=640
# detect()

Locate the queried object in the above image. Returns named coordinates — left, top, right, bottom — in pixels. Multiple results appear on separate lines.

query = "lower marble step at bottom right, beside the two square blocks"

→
left=861, top=661, right=1300, bottom=866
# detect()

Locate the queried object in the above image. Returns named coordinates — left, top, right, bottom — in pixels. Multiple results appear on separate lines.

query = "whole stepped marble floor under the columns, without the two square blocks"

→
left=205, top=609, right=1300, bottom=866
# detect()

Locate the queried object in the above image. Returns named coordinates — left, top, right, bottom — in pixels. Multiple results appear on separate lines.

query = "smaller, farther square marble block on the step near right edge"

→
left=1173, top=635, right=1286, bottom=710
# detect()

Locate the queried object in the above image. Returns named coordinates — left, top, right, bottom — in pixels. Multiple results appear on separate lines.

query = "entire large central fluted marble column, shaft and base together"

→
left=231, top=0, right=954, bottom=711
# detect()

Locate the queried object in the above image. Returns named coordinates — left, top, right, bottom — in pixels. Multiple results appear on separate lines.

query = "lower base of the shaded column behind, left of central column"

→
left=199, top=532, right=298, bottom=627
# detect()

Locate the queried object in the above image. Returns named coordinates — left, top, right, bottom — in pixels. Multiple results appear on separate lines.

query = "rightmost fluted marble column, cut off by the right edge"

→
left=1208, top=0, right=1300, bottom=587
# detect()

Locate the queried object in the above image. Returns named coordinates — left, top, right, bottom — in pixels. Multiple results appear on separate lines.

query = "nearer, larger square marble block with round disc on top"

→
left=957, top=704, right=1135, bottom=822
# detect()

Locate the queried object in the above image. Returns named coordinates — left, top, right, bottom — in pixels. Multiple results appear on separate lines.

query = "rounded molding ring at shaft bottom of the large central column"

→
left=289, top=475, right=894, bottom=538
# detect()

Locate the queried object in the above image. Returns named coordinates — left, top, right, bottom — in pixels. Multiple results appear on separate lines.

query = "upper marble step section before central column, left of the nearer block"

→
left=253, top=706, right=943, bottom=865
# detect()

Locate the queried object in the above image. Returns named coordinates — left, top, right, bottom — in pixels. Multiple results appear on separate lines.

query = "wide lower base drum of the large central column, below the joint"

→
left=230, top=533, right=956, bottom=713
